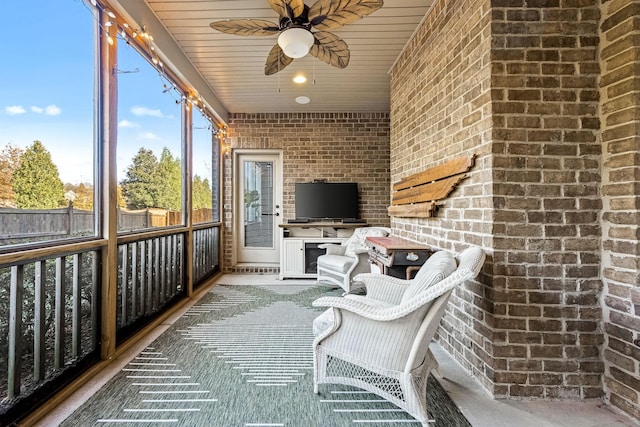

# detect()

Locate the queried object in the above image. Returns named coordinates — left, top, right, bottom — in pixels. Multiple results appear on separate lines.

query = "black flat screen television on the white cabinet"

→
left=295, top=182, right=359, bottom=220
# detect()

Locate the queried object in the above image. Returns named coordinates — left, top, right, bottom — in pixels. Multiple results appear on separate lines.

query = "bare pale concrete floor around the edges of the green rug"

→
left=35, top=274, right=640, bottom=427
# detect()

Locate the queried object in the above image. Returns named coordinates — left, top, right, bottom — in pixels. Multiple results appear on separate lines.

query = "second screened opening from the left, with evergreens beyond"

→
left=116, top=44, right=183, bottom=232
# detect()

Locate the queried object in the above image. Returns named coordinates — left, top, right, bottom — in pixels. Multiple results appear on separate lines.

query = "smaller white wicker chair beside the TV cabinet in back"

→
left=317, top=227, right=391, bottom=292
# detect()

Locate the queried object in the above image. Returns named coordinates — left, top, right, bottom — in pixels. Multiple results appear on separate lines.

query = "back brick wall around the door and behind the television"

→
left=224, top=113, right=390, bottom=271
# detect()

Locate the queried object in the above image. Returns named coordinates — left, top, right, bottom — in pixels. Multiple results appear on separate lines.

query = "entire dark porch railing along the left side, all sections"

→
left=0, top=223, right=221, bottom=424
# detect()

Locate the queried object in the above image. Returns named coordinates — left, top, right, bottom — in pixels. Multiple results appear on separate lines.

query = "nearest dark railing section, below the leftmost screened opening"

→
left=0, top=243, right=100, bottom=406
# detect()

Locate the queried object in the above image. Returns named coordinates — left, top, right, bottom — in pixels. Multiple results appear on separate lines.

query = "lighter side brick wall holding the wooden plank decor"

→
left=391, top=0, right=493, bottom=390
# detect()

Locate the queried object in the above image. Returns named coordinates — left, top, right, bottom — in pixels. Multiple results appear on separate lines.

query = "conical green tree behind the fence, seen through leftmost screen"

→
left=13, top=141, right=64, bottom=209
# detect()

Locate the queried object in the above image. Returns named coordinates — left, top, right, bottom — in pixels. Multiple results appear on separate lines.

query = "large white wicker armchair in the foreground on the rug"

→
left=313, top=247, right=485, bottom=426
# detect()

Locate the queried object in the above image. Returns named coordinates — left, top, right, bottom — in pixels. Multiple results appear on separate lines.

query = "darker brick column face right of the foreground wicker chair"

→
left=490, top=0, right=603, bottom=398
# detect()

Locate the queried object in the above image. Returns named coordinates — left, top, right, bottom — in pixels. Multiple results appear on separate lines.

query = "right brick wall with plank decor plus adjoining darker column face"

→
left=391, top=0, right=603, bottom=398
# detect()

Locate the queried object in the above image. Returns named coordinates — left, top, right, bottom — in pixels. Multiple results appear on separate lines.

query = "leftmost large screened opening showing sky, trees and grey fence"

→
left=0, top=1, right=97, bottom=248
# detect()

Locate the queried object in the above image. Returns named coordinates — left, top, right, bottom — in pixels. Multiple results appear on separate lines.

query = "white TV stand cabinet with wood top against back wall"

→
left=280, top=222, right=367, bottom=279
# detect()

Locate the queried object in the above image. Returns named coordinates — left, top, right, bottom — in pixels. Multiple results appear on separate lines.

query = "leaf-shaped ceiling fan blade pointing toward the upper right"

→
left=309, top=0, right=383, bottom=30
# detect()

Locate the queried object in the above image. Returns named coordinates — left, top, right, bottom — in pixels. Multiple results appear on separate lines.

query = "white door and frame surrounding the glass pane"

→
left=232, top=149, right=283, bottom=266
